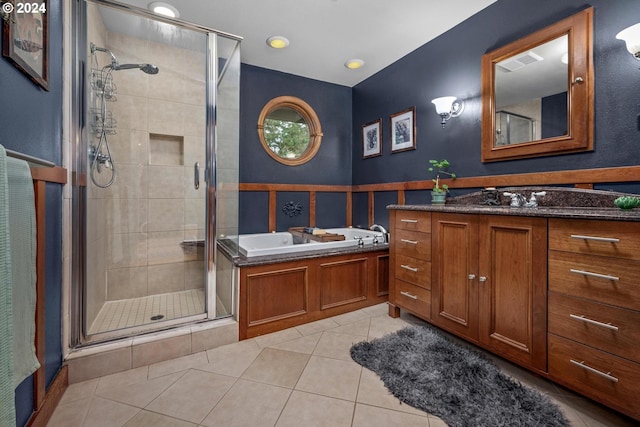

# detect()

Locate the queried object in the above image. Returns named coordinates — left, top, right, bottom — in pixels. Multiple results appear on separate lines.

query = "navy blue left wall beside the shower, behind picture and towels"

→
left=0, top=0, right=62, bottom=426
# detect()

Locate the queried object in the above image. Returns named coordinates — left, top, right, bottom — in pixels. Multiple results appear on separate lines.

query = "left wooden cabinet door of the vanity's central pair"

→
left=431, top=213, right=478, bottom=341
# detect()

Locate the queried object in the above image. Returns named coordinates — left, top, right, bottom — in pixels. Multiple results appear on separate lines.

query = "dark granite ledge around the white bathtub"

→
left=218, top=240, right=389, bottom=267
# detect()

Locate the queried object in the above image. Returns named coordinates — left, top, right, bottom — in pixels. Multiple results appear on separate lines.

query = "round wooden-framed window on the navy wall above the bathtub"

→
left=258, top=96, right=322, bottom=166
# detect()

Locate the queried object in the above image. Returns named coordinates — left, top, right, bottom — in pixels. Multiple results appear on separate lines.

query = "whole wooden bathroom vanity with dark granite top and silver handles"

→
left=388, top=188, right=640, bottom=419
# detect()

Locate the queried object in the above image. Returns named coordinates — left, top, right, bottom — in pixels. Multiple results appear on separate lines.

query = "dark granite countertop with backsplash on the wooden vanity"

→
left=387, top=187, right=640, bottom=222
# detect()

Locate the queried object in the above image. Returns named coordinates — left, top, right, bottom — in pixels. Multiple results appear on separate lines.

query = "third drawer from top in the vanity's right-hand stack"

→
left=549, top=292, right=640, bottom=363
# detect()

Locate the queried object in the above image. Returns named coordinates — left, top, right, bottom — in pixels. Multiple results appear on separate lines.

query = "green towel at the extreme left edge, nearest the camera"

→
left=0, top=145, right=16, bottom=426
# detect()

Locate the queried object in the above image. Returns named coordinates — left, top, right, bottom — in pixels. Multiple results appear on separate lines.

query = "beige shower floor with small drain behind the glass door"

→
left=89, top=289, right=205, bottom=335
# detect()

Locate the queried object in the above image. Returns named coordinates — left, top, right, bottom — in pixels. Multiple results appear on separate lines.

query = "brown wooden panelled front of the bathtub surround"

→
left=239, top=249, right=389, bottom=340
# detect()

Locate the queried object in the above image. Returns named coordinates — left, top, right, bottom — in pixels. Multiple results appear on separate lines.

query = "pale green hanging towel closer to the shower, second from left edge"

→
left=6, top=151, right=40, bottom=387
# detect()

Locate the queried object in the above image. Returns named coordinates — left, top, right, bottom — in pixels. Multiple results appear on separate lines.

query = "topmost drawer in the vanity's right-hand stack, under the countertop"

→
left=549, top=218, right=640, bottom=260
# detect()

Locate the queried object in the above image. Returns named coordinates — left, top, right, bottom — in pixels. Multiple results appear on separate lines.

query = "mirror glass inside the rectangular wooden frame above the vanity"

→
left=494, top=34, right=569, bottom=147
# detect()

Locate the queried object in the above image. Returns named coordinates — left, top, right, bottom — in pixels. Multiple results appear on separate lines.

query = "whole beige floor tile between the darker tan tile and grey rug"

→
left=295, top=356, right=362, bottom=401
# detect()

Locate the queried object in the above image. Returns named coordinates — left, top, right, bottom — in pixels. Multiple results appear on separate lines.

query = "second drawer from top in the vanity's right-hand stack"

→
left=548, top=251, right=640, bottom=310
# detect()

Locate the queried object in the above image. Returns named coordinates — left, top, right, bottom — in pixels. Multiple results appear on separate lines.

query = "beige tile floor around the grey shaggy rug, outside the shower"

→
left=48, top=304, right=638, bottom=427
